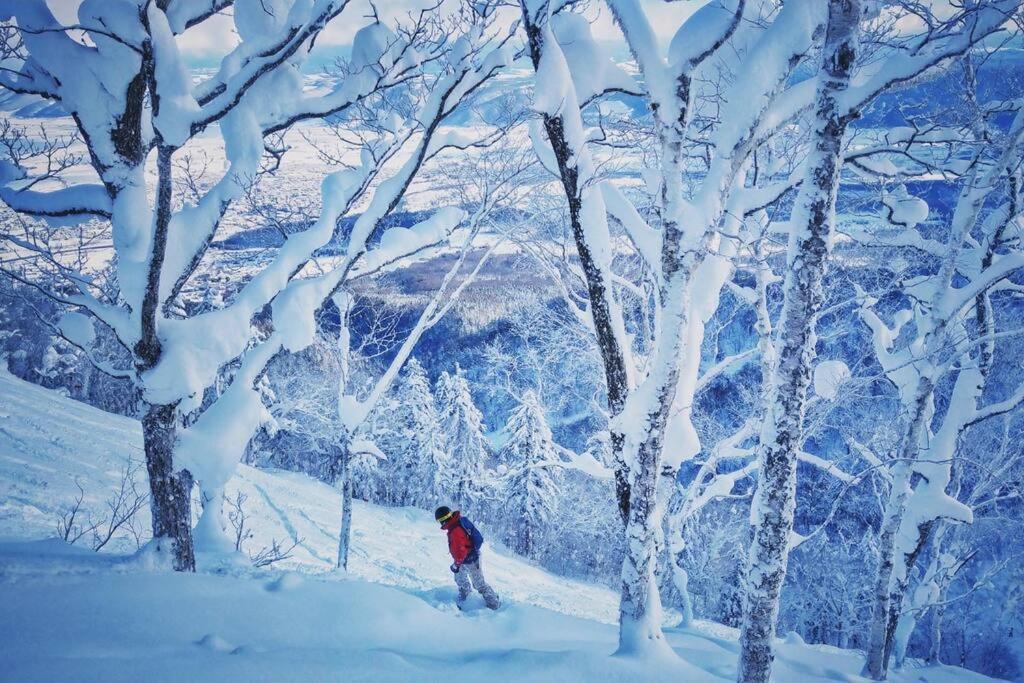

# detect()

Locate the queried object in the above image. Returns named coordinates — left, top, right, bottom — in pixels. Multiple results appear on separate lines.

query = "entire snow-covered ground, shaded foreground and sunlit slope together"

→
left=0, top=372, right=999, bottom=682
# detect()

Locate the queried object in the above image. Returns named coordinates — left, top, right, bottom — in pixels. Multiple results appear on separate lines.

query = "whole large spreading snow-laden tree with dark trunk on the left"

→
left=0, top=0, right=508, bottom=570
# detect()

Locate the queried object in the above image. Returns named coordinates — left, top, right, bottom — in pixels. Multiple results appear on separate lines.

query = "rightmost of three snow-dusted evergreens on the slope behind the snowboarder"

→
left=499, top=391, right=558, bottom=557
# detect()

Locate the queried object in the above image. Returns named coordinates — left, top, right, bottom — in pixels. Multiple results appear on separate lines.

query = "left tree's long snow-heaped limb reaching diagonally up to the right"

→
left=148, top=25, right=508, bottom=405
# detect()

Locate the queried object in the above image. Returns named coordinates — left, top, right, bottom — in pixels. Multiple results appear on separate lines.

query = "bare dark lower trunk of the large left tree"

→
left=142, top=405, right=196, bottom=571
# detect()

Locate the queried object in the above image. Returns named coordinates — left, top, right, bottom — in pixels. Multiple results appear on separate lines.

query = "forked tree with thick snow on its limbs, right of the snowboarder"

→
left=521, top=0, right=835, bottom=653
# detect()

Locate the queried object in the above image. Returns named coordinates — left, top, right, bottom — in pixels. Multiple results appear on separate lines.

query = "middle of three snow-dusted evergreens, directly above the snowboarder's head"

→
left=437, top=366, right=489, bottom=505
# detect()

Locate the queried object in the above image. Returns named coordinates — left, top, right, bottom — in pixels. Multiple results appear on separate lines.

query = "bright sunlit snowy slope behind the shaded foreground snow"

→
left=0, top=362, right=617, bottom=624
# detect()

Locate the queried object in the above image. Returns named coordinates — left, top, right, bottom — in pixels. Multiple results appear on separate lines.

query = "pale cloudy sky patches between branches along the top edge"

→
left=46, top=0, right=707, bottom=60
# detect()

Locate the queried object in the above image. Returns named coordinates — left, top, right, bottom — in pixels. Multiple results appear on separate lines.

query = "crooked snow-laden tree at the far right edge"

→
left=860, top=90, right=1024, bottom=679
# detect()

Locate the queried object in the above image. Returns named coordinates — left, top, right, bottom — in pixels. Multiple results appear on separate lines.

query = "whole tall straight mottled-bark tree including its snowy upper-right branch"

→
left=737, top=0, right=1014, bottom=682
